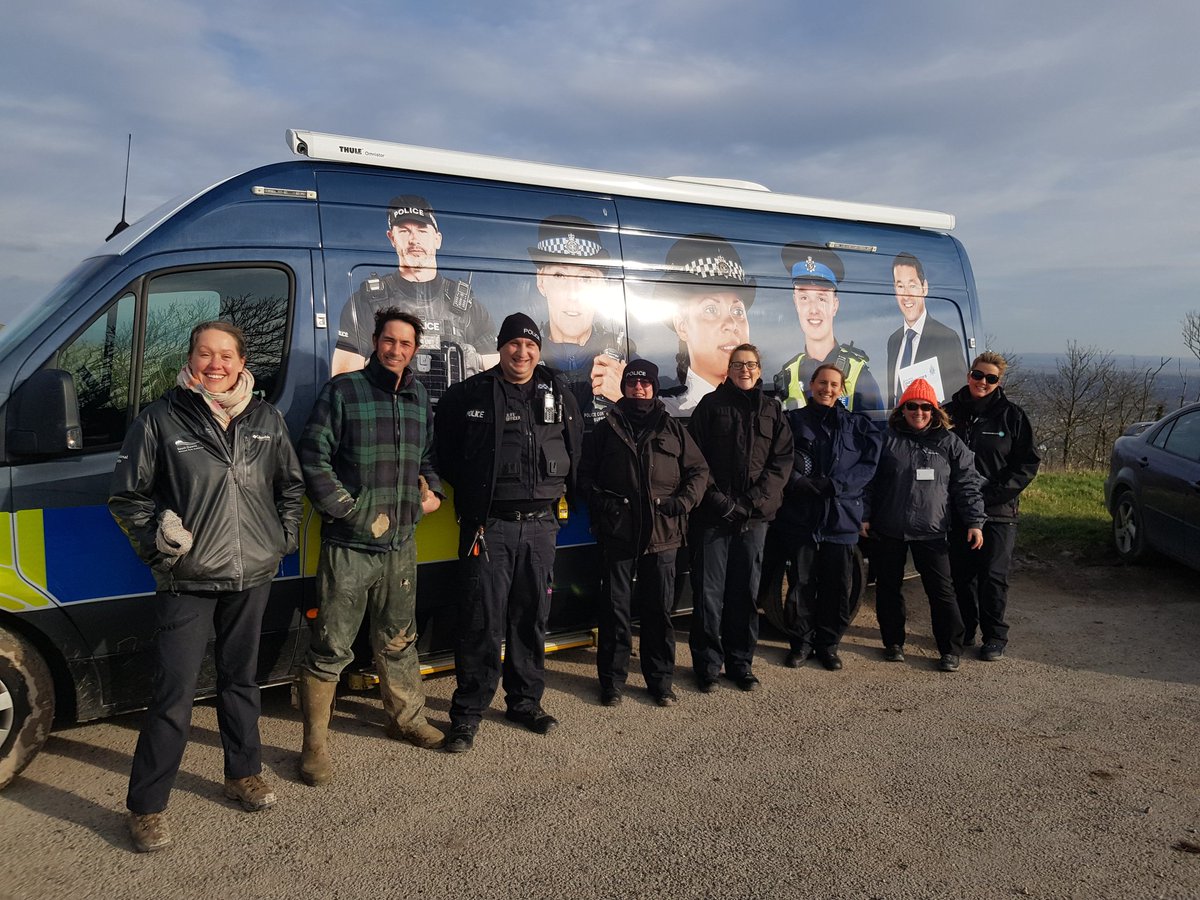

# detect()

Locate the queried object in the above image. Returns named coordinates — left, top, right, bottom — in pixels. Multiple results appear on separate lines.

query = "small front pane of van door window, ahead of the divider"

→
left=58, top=293, right=136, bottom=448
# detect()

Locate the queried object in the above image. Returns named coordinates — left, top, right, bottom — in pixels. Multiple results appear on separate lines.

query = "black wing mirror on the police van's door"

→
left=7, top=368, right=83, bottom=456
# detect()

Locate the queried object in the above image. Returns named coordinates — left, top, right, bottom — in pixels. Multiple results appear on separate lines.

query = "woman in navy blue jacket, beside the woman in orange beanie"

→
left=772, top=364, right=883, bottom=671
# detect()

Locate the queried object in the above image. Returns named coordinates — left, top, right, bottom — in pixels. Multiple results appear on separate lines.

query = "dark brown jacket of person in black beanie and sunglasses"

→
left=580, top=398, right=708, bottom=556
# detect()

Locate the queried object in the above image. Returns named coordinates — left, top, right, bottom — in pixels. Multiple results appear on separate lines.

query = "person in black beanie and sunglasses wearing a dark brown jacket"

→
left=580, top=359, right=708, bottom=707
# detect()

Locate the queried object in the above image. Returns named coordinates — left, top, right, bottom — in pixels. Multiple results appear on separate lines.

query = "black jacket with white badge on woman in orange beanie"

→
left=863, top=422, right=986, bottom=541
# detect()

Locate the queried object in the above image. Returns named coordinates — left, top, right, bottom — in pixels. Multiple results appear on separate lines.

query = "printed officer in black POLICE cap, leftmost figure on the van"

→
left=331, top=194, right=496, bottom=400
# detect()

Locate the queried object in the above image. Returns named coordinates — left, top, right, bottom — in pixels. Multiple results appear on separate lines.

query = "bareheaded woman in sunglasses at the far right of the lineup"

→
left=946, top=350, right=1042, bottom=662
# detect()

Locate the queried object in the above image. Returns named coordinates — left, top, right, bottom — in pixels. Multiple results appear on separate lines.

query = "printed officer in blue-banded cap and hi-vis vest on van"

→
left=775, top=241, right=883, bottom=413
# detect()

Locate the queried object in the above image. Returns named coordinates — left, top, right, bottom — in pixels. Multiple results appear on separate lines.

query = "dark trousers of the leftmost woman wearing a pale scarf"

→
left=125, top=582, right=271, bottom=815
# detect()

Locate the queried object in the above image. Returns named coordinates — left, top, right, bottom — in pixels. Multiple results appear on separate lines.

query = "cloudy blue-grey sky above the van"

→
left=0, top=0, right=1200, bottom=356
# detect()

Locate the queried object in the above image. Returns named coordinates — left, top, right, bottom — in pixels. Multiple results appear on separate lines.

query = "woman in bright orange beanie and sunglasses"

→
left=862, top=378, right=985, bottom=672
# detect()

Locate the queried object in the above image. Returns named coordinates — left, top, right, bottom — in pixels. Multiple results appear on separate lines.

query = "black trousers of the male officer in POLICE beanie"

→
left=450, top=516, right=558, bottom=727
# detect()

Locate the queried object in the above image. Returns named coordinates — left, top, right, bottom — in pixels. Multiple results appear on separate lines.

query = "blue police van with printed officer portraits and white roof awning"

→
left=0, top=131, right=983, bottom=787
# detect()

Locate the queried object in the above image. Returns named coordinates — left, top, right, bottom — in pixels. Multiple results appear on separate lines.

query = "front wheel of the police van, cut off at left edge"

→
left=0, top=628, right=54, bottom=788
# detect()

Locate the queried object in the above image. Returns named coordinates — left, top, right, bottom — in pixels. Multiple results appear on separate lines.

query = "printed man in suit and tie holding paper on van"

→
left=888, top=253, right=967, bottom=409
